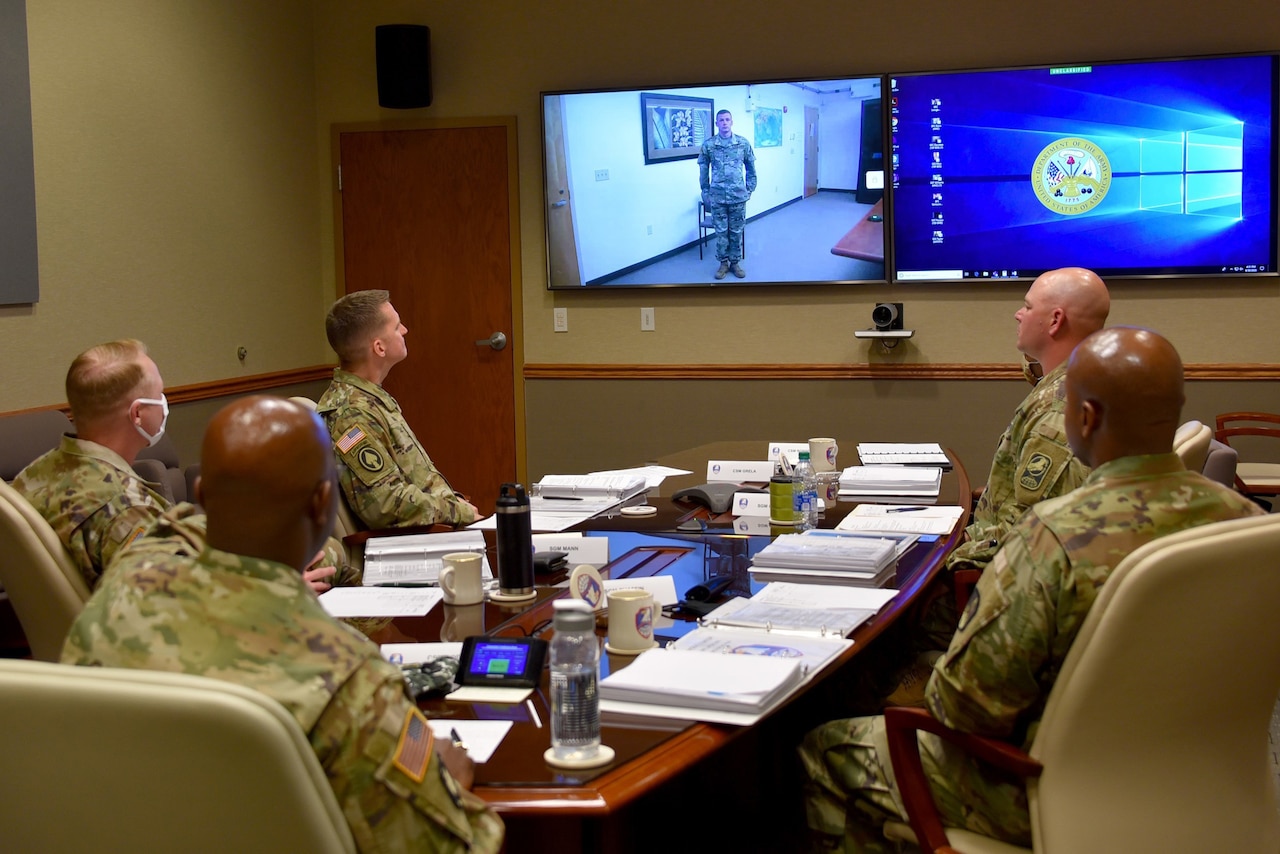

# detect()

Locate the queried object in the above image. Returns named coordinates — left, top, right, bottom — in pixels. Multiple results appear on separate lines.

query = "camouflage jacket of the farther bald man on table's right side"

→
left=947, top=361, right=1089, bottom=568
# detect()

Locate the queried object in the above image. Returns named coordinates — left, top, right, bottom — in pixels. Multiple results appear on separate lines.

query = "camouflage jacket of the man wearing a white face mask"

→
left=13, top=435, right=169, bottom=590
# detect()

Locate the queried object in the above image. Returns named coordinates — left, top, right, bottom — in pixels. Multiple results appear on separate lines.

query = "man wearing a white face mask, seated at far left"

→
left=13, top=339, right=360, bottom=590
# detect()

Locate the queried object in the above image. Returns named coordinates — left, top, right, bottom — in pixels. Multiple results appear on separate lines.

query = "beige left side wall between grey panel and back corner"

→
left=0, top=0, right=332, bottom=411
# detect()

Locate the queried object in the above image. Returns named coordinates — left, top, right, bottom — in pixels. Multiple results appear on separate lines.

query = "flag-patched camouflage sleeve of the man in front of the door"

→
left=332, top=415, right=475, bottom=529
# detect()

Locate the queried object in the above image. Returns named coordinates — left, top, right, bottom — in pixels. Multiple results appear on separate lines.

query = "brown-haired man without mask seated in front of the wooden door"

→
left=317, top=291, right=477, bottom=529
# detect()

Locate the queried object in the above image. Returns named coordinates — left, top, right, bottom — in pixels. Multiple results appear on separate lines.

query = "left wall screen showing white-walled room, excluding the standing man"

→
left=541, top=76, right=888, bottom=289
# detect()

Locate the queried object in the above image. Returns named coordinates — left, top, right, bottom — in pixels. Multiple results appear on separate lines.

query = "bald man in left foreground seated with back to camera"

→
left=63, top=397, right=503, bottom=851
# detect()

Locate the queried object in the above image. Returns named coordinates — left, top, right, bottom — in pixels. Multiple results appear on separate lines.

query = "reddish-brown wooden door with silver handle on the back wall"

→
left=334, top=119, right=525, bottom=515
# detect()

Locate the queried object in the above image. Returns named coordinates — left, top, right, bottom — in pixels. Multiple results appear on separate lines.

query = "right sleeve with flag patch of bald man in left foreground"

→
left=310, top=661, right=503, bottom=851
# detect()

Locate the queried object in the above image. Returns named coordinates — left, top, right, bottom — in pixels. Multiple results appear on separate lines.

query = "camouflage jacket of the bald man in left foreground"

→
left=63, top=522, right=503, bottom=851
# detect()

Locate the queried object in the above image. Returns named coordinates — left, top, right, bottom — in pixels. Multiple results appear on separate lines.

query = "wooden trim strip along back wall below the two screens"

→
left=524, top=362, right=1280, bottom=380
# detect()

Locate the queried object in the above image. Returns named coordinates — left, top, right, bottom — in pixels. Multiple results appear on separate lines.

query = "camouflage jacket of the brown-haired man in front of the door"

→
left=316, top=369, right=475, bottom=529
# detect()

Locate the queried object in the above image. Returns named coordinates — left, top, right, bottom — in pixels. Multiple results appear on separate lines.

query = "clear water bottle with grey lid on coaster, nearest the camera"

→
left=550, top=599, right=600, bottom=762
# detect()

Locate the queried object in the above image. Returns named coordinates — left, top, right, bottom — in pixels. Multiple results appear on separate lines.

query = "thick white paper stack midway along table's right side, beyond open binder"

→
left=750, top=531, right=897, bottom=586
